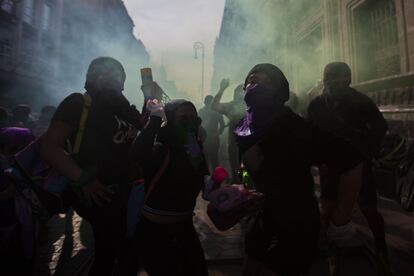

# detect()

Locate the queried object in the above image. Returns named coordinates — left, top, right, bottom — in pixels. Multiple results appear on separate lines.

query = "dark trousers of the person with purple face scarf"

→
left=245, top=214, right=319, bottom=275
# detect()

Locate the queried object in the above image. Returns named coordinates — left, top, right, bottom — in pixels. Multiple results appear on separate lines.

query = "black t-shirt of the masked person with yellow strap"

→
left=53, top=93, right=139, bottom=188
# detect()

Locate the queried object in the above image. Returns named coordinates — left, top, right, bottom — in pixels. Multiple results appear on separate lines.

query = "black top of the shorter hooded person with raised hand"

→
left=132, top=116, right=209, bottom=213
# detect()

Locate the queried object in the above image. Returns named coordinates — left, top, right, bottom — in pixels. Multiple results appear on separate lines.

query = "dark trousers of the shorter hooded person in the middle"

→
left=138, top=218, right=207, bottom=276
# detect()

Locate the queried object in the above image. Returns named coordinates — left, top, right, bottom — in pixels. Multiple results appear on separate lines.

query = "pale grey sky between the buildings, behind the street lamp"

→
left=124, top=0, right=225, bottom=101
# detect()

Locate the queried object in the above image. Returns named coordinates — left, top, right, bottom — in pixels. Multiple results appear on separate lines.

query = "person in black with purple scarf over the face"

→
left=238, top=64, right=359, bottom=275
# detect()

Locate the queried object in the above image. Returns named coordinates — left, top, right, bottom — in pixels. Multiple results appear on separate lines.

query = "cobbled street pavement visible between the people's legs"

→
left=34, top=194, right=414, bottom=276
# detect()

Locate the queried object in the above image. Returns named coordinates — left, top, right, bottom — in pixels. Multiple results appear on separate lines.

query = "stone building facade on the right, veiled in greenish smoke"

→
left=213, top=0, right=414, bottom=122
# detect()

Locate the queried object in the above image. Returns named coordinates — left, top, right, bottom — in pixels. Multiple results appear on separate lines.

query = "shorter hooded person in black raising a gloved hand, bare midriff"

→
left=131, top=100, right=209, bottom=276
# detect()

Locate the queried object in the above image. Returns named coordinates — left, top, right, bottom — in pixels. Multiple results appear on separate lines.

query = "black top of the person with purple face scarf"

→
left=242, top=111, right=362, bottom=223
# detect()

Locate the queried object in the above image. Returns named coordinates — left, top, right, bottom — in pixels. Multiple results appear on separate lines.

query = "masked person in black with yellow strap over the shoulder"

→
left=41, top=57, right=140, bottom=275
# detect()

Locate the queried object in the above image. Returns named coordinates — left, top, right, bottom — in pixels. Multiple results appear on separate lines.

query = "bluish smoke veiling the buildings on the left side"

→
left=0, top=0, right=149, bottom=111
